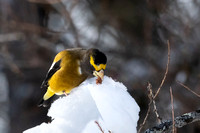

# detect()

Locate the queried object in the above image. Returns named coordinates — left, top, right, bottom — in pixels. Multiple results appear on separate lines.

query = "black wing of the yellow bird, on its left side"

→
left=41, top=60, right=61, bottom=88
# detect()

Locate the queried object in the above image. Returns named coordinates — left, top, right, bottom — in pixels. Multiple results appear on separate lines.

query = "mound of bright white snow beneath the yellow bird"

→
left=24, top=76, right=140, bottom=133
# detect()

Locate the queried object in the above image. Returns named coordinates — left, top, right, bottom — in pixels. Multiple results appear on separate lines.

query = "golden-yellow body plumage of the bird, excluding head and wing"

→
left=44, top=50, right=87, bottom=100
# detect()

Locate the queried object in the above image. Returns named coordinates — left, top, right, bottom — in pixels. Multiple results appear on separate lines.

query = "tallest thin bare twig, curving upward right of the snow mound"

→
left=153, top=40, right=170, bottom=99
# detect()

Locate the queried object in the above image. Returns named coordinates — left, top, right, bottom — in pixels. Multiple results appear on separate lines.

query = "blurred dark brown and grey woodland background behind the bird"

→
left=0, top=0, right=200, bottom=133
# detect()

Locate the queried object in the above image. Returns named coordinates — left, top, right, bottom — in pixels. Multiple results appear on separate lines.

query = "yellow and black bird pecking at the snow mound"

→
left=38, top=48, right=107, bottom=107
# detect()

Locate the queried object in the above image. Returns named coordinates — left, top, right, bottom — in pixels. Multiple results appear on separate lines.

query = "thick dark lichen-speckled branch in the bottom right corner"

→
left=144, top=110, right=200, bottom=133
